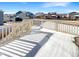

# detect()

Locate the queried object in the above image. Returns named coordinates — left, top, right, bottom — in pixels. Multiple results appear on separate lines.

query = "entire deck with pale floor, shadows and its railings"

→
left=0, top=19, right=79, bottom=57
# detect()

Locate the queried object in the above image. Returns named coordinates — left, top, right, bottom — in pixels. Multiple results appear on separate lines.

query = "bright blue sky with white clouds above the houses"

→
left=0, top=2, right=79, bottom=14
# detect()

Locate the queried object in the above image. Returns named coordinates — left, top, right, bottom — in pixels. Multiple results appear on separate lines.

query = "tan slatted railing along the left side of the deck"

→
left=0, top=20, right=33, bottom=43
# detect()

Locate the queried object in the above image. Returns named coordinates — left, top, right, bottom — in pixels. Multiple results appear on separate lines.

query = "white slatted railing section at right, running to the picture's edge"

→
left=57, top=24, right=79, bottom=35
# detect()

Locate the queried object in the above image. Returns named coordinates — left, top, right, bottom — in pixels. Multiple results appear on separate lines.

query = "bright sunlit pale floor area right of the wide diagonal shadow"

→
left=35, top=28, right=79, bottom=57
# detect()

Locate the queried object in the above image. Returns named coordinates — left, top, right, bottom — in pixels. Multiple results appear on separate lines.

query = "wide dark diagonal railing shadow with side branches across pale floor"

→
left=24, top=31, right=53, bottom=57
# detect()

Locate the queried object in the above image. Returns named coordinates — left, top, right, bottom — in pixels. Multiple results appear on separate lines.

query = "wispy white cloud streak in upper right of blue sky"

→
left=42, top=2, right=70, bottom=8
